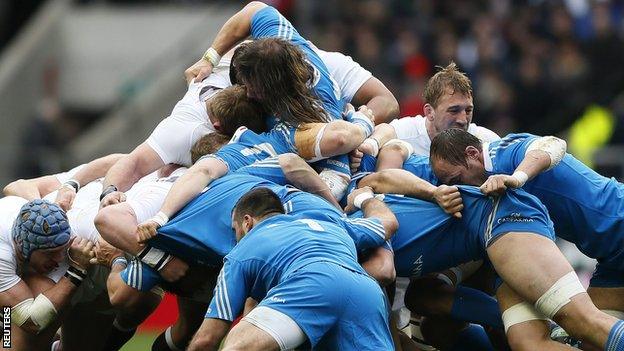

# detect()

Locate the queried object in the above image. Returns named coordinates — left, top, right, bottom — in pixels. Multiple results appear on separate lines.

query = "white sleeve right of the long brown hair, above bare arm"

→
left=317, top=49, right=373, bottom=102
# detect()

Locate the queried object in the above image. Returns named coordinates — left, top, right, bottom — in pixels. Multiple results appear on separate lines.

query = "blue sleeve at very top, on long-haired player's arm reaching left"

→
left=251, top=6, right=307, bottom=45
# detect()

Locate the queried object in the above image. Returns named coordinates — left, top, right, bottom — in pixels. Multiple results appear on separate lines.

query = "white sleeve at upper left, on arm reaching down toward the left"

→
left=147, top=116, right=208, bottom=166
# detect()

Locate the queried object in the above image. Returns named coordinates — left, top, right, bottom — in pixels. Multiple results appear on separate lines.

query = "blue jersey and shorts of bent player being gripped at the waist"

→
left=352, top=186, right=554, bottom=277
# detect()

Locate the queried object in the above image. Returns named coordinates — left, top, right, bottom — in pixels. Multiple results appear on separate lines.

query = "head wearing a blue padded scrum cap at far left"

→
left=12, top=199, right=71, bottom=274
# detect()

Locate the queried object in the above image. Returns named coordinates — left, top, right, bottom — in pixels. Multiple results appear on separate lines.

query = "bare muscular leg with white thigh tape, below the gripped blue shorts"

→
left=487, top=232, right=624, bottom=347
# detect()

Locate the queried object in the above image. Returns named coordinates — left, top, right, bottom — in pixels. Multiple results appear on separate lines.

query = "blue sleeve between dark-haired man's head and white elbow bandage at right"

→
left=489, top=133, right=537, bottom=174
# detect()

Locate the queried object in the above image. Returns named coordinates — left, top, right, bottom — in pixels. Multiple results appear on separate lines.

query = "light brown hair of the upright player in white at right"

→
left=423, top=61, right=472, bottom=108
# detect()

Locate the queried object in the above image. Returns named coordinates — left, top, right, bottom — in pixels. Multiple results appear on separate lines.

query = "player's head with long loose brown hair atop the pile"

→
left=230, top=38, right=328, bottom=126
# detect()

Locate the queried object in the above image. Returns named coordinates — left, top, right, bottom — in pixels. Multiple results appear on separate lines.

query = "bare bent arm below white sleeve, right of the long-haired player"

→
left=351, top=77, right=399, bottom=124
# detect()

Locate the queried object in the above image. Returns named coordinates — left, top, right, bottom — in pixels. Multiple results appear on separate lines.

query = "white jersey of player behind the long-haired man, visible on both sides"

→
left=147, top=49, right=372, bottom=167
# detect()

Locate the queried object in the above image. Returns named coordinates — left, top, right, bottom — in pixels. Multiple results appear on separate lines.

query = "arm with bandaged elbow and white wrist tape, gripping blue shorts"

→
left=480, top=136, right=567, bottom=195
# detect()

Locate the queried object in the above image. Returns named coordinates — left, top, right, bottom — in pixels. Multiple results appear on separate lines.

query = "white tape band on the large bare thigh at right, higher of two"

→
left=535, top=271, right=585, bottom=319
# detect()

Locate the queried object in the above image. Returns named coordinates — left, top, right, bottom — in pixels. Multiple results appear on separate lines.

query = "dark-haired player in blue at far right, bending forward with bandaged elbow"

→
left=431, top=130, right=624, bottom=350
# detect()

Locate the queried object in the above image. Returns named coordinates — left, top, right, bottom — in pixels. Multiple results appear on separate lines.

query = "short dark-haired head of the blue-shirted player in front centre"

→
left=232, top=188, right=284, bottom=240
